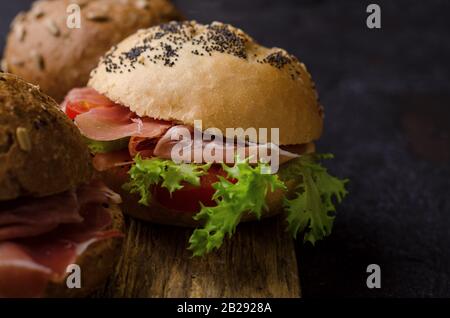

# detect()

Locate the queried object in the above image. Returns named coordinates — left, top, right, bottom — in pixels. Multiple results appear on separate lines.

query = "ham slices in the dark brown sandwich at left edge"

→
left=0, top=183, right=121, bottom=297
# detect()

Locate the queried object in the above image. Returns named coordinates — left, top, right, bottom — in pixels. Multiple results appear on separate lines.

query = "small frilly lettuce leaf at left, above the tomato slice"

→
left=123, top=155, right=210, bottom=206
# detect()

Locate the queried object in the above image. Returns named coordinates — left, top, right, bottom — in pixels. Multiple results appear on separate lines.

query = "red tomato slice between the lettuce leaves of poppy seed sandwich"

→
left=153, top=166, right=232, bottom=213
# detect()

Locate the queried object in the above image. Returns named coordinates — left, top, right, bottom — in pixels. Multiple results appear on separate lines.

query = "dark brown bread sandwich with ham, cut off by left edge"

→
left=0, top=73, right=124, bottom=298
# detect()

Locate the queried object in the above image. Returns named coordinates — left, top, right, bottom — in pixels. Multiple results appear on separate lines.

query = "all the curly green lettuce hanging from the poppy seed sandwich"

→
left=124, top=155, right=347, bottom=256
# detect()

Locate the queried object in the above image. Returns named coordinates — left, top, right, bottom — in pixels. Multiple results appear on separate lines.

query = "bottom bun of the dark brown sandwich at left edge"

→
left=44, top=204, right=124, bottom=298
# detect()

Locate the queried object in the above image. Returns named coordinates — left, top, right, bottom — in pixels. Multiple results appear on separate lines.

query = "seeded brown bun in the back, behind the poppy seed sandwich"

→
left=3, top=0, right=181, bottom=102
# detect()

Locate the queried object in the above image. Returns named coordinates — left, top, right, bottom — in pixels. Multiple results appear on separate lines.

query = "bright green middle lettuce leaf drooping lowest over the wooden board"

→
left=189, top=159, right=286, bottom=256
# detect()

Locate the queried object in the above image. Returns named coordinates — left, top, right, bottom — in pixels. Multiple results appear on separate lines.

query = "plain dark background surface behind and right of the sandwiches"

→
left=0, top=0, right=450, bottom=297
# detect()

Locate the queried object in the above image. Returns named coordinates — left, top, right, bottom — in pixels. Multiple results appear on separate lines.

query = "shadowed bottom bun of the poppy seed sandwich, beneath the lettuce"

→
left=99, top=167, right=296, bottom=227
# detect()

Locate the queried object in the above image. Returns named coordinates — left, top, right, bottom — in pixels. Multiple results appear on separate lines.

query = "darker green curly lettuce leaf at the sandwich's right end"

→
left=280, top=155, right=348, bottom=245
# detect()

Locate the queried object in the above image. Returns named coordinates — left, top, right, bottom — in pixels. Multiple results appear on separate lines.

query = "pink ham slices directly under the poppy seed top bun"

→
left=63, top=88, right=298, bottom=171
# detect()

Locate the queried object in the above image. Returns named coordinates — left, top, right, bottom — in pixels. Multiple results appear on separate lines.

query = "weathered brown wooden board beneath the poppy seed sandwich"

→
left=98, top=218, right=301, bottom=298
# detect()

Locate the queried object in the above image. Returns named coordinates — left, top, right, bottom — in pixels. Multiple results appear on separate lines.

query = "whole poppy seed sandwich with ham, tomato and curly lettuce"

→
left=62, top=21, right=347, bottom=255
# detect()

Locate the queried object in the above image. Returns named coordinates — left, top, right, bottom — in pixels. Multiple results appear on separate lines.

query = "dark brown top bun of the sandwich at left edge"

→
left=0, top=73, right=92, bottom=201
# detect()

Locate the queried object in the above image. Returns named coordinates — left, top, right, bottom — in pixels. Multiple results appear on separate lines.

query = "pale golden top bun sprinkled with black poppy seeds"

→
left=89, top=21, right=323, bottom=145
